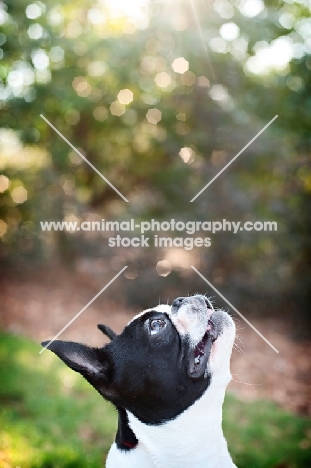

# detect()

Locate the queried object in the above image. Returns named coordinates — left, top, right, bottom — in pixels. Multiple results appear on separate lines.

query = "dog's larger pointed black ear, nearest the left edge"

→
left=41, top=340, right=113, bottom=399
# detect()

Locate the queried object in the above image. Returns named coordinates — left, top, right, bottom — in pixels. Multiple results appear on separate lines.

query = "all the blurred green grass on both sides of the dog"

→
left=0, top=334, right=311, bottom=468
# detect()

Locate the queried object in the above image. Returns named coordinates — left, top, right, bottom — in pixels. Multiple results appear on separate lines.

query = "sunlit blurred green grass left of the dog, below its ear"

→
left=0, top=335, right=117, bottom=468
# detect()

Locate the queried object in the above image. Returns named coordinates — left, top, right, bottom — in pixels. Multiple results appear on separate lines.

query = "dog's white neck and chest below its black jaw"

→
left=107, top=366, right=235, bottom=468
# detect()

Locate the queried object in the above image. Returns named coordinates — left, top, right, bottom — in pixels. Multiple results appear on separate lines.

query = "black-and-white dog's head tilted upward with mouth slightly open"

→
left=42, top=295, right=235, bottom=424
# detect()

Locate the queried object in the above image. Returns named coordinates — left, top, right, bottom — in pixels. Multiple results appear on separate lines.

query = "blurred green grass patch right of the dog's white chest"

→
left=223, top=395, right=311, bottom=468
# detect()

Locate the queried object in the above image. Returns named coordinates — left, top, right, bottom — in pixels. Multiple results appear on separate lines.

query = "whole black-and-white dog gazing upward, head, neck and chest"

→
left=42, top=294, right=235, bottom=468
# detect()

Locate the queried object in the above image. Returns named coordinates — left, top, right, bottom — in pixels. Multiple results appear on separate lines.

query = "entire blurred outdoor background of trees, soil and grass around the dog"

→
left=0, top=0, right=311, bottom=468
